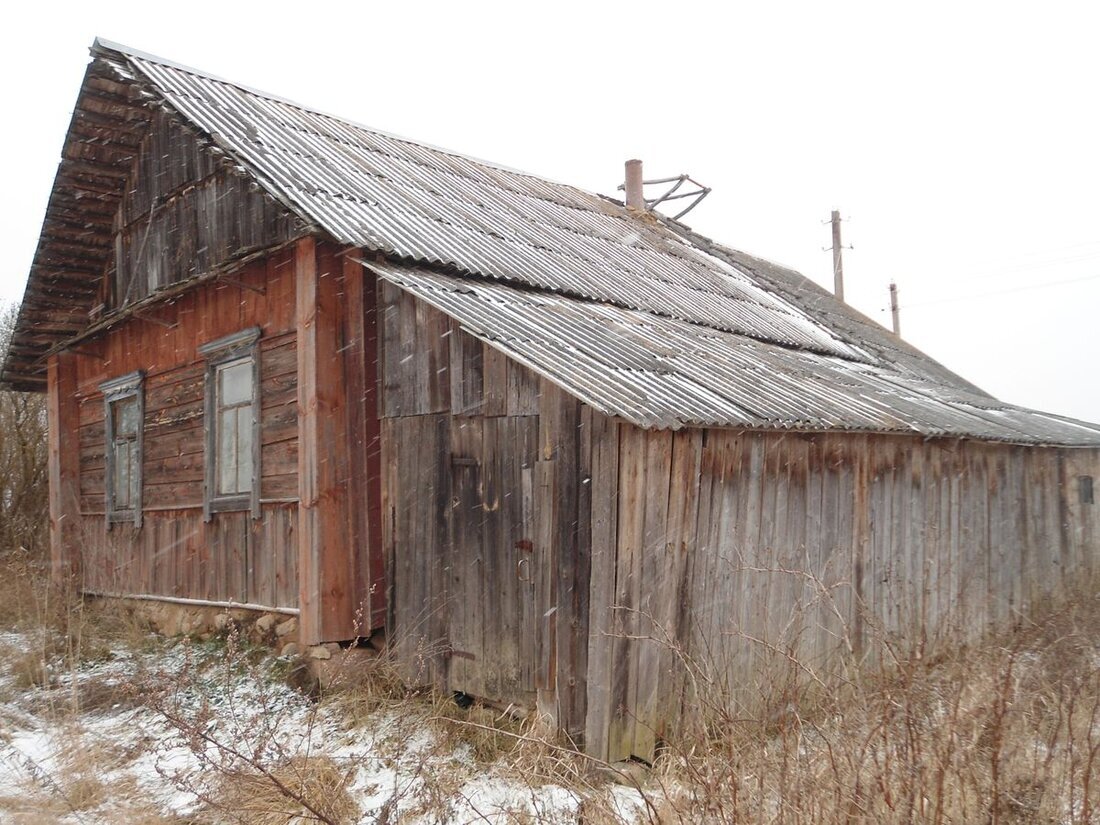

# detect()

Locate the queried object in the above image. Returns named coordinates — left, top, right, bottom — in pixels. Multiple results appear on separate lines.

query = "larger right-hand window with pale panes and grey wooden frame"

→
left=199, top=327, right=260, bottom=520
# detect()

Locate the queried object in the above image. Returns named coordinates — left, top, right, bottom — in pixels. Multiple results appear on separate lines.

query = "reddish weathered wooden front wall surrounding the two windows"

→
left=72, top=252, right=298, bottom=608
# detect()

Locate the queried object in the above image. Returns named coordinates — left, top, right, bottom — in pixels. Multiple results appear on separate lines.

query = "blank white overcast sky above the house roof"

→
left=0, top=0, right=1100, bottom=421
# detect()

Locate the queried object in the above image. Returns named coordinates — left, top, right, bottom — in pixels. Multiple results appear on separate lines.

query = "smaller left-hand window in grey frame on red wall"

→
left=99, top=371, right=145, bottom=527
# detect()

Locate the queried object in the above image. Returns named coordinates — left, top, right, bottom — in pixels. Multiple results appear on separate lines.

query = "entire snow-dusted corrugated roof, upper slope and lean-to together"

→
left=6, top=41, right=1100, bottom=446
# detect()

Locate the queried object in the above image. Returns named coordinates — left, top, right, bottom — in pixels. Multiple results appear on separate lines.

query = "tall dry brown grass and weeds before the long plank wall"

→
left=653, top=593, right=1100, bottom=825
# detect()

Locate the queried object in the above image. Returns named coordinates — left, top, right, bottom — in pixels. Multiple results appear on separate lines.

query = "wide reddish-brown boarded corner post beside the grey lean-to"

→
left=295, top=238, right=384, bottom=642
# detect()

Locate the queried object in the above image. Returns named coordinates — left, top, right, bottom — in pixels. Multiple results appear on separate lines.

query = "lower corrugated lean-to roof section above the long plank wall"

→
left=365, top=262, right=1100, bottom=446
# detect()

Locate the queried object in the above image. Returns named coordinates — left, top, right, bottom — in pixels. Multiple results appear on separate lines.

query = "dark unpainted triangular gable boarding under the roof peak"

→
left=103, top=110, right=304, bottom=308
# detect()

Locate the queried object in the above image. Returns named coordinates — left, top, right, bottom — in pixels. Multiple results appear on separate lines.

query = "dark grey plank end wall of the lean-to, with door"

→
left=380, top=282, right=593, bottom=736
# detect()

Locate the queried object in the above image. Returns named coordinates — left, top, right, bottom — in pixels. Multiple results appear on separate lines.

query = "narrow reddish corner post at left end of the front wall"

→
left=46, top=352, right=80, bottom=586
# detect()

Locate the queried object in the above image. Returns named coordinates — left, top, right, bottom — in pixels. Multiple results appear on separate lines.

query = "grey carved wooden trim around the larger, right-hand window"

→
left=198, top=327, right=263, bottom=521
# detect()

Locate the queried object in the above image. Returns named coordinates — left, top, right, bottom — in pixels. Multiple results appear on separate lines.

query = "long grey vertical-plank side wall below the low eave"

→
left=586, top=424, right=1100, bottom=760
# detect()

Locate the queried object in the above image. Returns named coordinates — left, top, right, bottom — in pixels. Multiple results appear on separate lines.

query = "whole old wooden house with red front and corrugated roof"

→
left=2, top=41, right=1100, bottom=759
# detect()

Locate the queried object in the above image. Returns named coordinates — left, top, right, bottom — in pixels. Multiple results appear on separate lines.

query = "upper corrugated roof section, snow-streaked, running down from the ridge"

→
left=116, top=47, right=864, bottom=359
